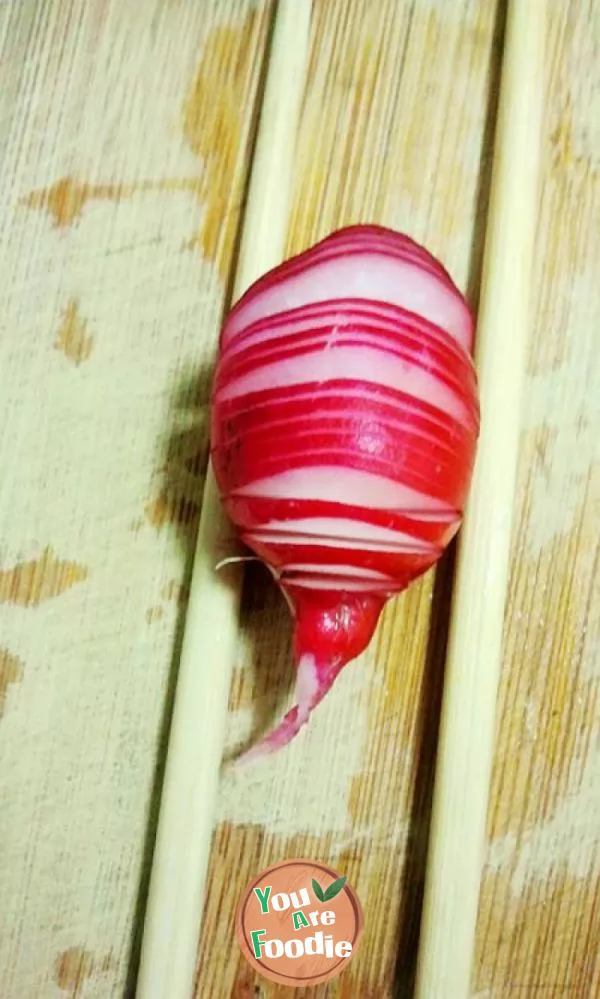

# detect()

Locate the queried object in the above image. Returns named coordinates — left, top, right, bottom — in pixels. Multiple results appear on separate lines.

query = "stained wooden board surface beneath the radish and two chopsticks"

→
left=0, top=0, right=600, bottom=999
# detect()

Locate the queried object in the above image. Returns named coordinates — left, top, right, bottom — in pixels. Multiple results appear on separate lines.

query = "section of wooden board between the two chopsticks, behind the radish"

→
left=196, top=0, right=506, bottom=997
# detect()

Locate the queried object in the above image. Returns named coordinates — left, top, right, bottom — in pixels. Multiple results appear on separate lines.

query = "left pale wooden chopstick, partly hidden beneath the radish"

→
left=136, top=0, right=310, bottom=999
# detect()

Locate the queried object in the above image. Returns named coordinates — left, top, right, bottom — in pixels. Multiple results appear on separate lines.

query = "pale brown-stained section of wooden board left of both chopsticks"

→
left=0, top=0, right=270, bottom=999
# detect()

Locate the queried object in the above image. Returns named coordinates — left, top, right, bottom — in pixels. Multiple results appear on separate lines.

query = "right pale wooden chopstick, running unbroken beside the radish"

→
left=416, top=0, right=546, bottom=999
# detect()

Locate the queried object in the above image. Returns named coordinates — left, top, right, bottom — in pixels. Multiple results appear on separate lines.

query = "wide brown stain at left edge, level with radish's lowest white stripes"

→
left=0, top=546, right=89, bottom=607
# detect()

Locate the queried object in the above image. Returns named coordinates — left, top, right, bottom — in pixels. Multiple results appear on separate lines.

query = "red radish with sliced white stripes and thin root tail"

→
left=211, top=225, right=479, bottom=761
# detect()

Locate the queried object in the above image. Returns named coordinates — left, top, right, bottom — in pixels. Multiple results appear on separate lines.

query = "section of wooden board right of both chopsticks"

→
left=473, top=0, right=600, bottom=999
